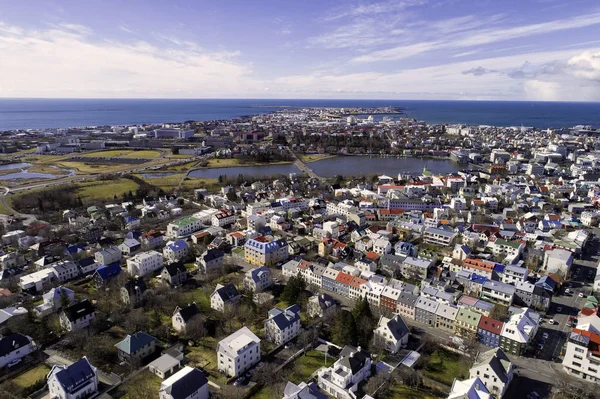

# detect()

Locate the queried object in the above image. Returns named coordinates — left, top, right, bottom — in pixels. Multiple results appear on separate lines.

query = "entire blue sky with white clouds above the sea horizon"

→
left=0, top=0, right=600, bottom=101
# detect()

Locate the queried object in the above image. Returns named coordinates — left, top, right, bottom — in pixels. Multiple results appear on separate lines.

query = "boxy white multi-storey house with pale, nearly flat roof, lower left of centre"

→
left=217, top=326, right=260, bottom=377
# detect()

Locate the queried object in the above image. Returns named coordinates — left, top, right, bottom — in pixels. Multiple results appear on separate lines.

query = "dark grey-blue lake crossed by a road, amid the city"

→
left=189, top=156, right=461, bottom=179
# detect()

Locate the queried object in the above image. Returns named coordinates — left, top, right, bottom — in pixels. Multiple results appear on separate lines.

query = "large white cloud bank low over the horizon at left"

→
left=0, top=24, right=262, bottom=98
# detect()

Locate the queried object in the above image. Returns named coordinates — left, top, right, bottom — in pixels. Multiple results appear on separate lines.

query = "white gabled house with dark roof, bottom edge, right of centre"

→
left=469, top=348, right=514, bottom=399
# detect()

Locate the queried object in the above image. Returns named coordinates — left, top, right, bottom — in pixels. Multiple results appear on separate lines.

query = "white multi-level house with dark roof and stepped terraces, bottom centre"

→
left=318, top=345, right=371, bottom=399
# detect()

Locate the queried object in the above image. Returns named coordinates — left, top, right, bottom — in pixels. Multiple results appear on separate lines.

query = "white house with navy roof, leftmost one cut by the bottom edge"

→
left=48, top=356, right=98, bottom=399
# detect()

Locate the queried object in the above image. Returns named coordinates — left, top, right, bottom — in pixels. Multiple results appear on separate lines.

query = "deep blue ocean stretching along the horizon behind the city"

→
left=0, top=99, right=600, bottom=130
